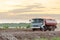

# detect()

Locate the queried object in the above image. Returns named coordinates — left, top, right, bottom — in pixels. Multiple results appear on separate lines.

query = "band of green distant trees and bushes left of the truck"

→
left=0, top=23, right=31, bottom=28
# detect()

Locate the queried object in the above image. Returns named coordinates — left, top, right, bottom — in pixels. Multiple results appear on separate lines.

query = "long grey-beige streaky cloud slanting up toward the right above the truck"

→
left=8, top=4, right=45, bottom=13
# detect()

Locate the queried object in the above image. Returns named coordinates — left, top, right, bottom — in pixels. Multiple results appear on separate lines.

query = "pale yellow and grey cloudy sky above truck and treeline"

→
left=0, top=0, right=60, bottom=23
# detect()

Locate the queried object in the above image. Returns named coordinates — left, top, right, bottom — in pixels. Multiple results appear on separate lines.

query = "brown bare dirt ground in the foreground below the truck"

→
left=0, top=29, right=60, bottom=40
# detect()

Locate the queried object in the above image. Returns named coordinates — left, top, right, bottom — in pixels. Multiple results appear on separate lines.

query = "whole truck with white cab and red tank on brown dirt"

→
left=31, top=18, right=57, bottom=31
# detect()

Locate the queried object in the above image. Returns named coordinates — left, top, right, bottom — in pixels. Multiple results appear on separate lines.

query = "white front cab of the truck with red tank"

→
left=31, top=18, right=44, bottom=30
